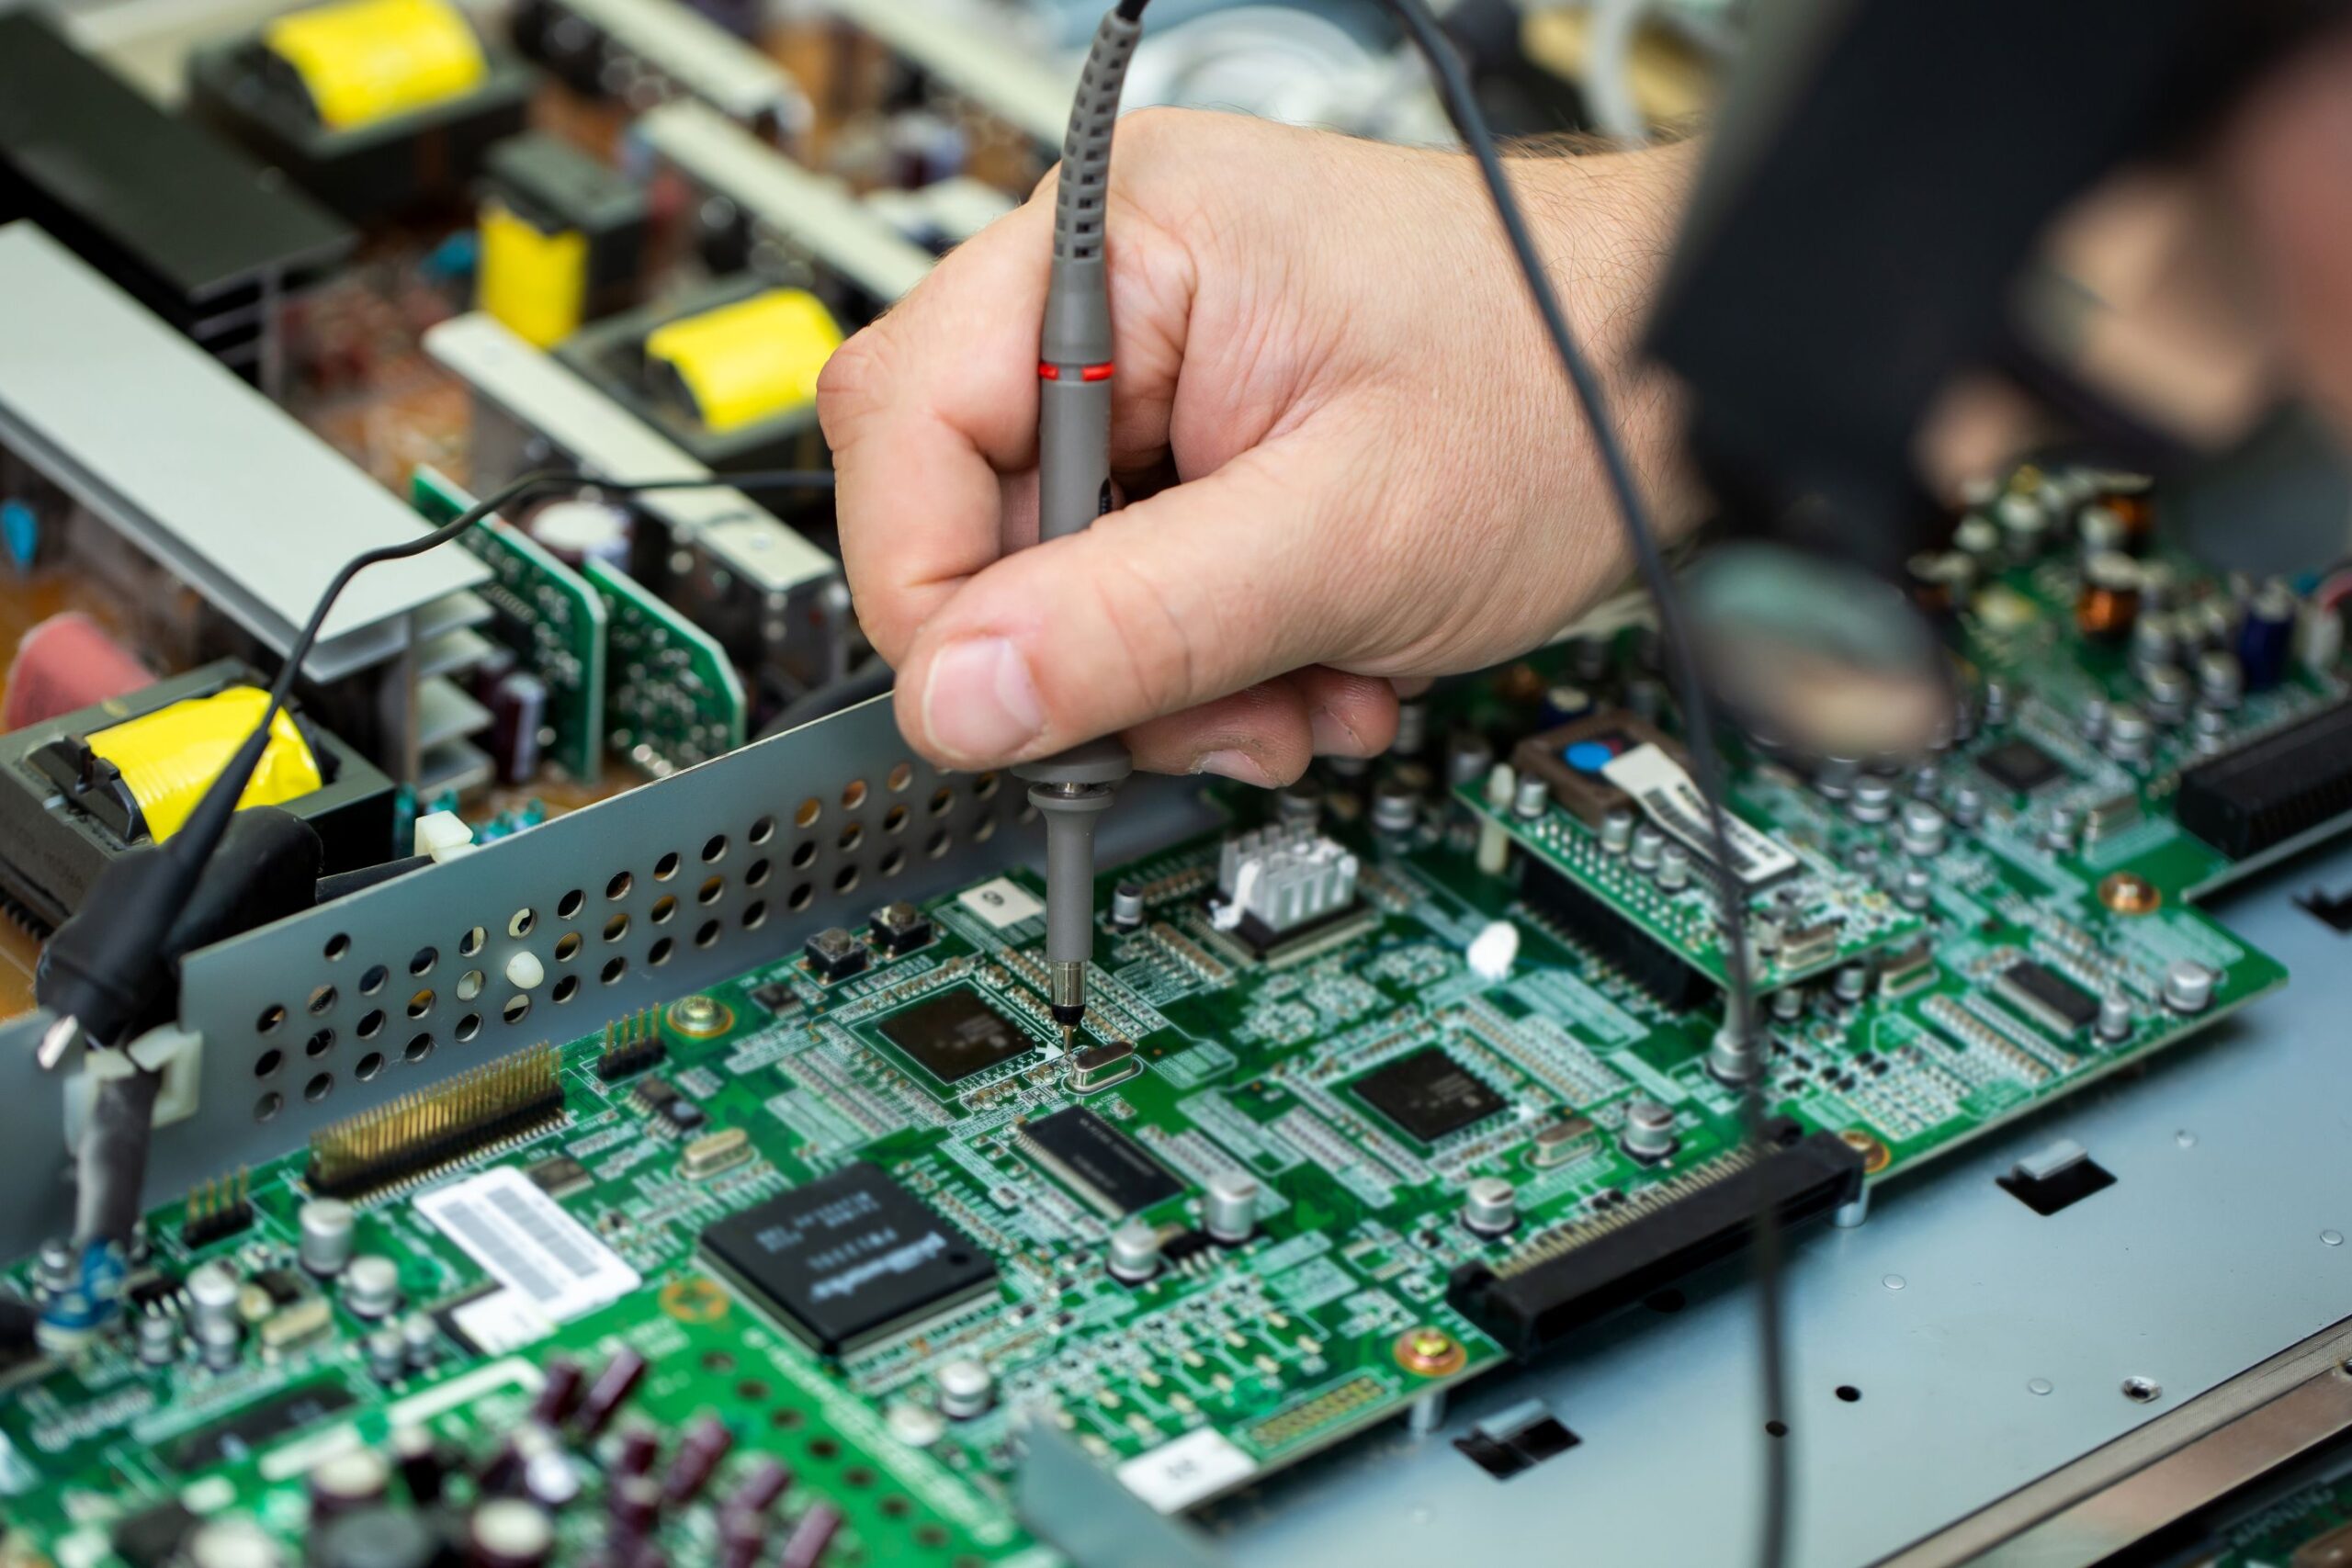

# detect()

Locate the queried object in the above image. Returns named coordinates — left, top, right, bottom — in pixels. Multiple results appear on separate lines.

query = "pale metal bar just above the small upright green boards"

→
left=425, top=310, right=840, bottom=594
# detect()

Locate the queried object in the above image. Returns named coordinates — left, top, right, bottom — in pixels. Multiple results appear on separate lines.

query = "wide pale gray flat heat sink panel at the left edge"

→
left=0, top=223, right=489, bottom=680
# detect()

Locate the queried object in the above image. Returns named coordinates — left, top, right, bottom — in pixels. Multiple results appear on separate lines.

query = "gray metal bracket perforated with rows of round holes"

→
left=0, top=698, right=1200, bottom=1258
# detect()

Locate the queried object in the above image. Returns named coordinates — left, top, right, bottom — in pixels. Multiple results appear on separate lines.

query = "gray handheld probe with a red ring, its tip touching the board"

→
left=1013, top=0, right=1143, bottom=1030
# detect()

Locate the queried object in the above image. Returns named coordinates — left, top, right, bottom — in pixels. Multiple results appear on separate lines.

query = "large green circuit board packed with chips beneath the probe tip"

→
left=0, top=469, right=2340, bottom=1568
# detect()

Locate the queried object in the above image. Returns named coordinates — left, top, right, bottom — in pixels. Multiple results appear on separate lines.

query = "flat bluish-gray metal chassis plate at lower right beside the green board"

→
left=1221, top=846, right=2352, bottom=1568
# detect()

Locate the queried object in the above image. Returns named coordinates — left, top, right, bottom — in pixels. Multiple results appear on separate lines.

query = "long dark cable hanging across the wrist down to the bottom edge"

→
left=1385, top=0, right=1790, bottom=1568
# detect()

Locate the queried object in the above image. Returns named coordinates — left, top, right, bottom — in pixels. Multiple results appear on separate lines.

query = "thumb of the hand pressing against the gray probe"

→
left=899, top=445, right=1360, bottom=769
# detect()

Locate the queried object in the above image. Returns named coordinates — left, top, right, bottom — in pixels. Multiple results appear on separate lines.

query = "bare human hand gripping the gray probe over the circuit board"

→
left=819, top=110, right=1696, bottom=785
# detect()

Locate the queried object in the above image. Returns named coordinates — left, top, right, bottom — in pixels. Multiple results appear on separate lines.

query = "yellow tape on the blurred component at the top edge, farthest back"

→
left=261, top=0, right=489, bottom=131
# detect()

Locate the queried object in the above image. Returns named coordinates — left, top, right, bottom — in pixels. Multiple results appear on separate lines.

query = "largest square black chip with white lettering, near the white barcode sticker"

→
left=703, top=1161, right=997, bottom=1357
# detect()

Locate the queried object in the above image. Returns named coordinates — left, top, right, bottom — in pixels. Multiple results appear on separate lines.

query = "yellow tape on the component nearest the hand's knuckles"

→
left=644, top=289, right=842, bottom=433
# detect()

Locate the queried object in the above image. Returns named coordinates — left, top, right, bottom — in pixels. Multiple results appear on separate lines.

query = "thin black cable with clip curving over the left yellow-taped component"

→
left=38, top=468, right=832, bottom=1244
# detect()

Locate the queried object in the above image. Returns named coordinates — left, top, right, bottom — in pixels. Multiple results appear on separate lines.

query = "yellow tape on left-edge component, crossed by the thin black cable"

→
left=87, top=686, right=324, bottom=844
